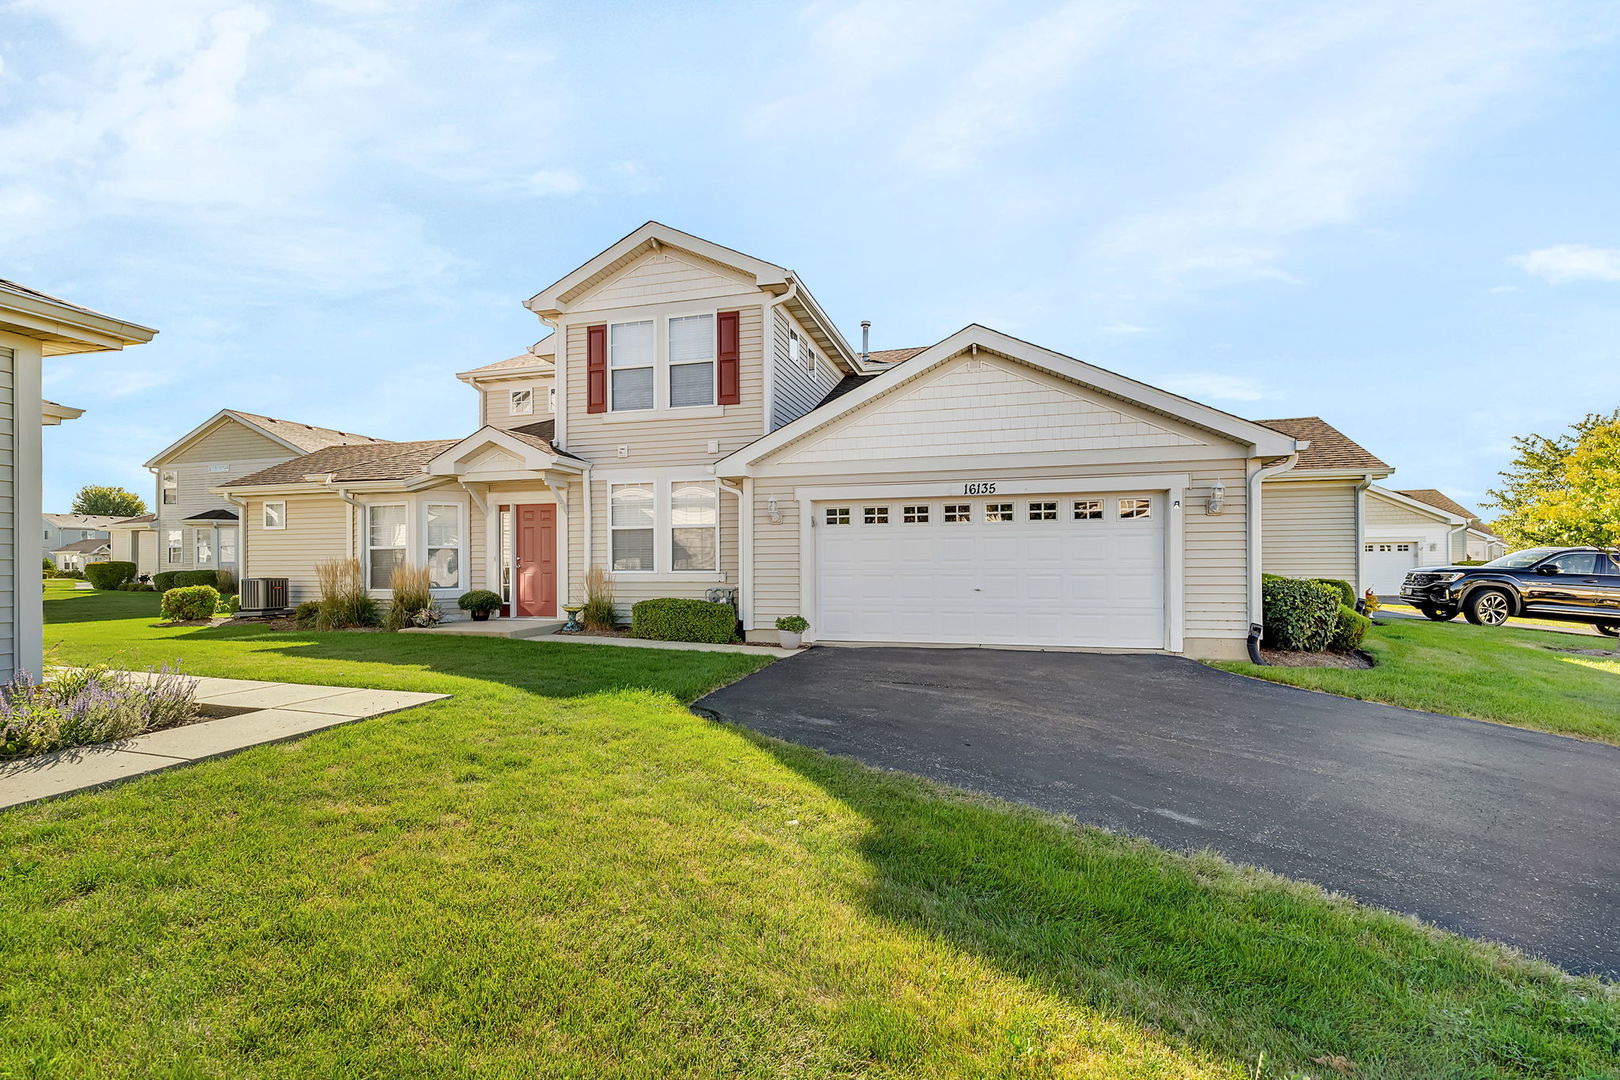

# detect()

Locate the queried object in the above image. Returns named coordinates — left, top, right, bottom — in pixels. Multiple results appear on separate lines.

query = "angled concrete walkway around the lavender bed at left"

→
left=0, top=678, right=450, bottom=808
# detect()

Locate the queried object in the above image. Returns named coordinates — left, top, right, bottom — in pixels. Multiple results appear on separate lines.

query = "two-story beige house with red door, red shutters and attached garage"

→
left=202, top=222, right=1445, bottom=656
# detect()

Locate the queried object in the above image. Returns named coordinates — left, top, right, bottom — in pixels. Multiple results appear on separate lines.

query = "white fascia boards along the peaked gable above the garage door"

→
left=714, top=322, right=1299, bottom=476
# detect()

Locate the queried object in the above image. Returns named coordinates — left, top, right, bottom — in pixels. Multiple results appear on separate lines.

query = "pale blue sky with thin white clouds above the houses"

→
left=9, top=0, right=1620, bottom=508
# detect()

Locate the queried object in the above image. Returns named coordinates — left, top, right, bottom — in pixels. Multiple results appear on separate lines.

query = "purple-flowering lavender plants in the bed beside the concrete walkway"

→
left=0, top=664, right=198, bottom=758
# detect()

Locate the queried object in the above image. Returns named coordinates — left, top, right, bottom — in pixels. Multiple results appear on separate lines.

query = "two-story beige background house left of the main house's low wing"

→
left=142, top=410, right=392, bottom=586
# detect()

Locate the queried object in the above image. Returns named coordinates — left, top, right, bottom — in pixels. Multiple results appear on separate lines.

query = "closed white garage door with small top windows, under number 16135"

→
left=812, top=494, right=1166, bottom=649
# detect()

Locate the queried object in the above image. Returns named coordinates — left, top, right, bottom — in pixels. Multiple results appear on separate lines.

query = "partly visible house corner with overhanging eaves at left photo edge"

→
left=0, top=280, right=156, bottom=680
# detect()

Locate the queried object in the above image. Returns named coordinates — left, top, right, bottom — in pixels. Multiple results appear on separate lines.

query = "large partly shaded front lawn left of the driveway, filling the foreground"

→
left=0, top=589, right=1620, bottom=1080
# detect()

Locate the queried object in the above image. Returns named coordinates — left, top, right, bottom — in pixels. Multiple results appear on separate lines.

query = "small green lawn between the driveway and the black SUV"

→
left=1217, top=619, right=1620, bottom=745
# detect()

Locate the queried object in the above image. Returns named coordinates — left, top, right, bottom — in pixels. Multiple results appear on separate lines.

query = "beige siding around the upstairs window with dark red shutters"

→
left=561, top=306, right=765, bottom=468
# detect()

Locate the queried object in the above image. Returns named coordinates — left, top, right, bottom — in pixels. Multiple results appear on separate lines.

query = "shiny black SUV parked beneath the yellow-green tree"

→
left=1401, top=547, right=1620, bottom=636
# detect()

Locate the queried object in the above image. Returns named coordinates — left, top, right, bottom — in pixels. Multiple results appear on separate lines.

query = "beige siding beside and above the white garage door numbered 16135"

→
left=750, top=458, right=1249, bottom=640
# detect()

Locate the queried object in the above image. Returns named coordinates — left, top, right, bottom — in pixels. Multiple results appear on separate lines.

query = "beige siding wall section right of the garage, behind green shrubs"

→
left=1260, top=481, right=1361, bottom=586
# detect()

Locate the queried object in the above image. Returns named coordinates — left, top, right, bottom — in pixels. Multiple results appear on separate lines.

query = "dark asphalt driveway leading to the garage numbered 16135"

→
left=695, top=648, right=1620, bottom=978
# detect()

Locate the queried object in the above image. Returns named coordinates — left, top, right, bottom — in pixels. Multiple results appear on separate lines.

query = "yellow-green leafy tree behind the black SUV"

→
left=1484, top=410, right=1620, bottom=547
